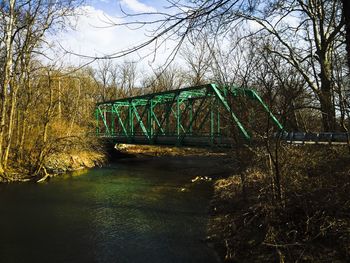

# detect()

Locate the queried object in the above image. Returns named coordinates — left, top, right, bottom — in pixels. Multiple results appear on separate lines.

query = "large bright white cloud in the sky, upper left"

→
left=48, top=6, right=173, bottom=68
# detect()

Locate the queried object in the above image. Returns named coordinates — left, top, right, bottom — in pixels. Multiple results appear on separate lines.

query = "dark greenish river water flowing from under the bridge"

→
left=0, top=158, right=218, bottom=263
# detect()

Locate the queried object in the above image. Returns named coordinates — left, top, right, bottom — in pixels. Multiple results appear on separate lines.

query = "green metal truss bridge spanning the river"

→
left=96, top=84, right=283, bottom=146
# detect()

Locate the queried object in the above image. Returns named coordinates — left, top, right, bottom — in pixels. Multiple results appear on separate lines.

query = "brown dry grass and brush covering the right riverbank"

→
left=210, top=146, right=350, bottom=262
